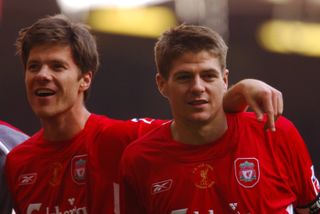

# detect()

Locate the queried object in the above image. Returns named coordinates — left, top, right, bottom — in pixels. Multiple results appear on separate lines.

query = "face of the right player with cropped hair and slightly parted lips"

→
left=157, top=51, right=228, bottom=124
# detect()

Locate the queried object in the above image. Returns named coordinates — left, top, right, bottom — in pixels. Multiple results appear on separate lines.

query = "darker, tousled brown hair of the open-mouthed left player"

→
left=16, top=14, right=99, bottom=97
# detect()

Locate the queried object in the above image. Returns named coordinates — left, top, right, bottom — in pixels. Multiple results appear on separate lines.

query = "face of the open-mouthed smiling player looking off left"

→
left=25, top=44, right=92, bottom=119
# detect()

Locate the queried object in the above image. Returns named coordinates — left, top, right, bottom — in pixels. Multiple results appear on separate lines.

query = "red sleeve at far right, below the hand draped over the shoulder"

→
left=272, top=118, right=320, bottom=209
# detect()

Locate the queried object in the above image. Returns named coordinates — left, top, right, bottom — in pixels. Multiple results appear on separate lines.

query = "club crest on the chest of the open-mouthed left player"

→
left=71, top=155, right=88, bottom=184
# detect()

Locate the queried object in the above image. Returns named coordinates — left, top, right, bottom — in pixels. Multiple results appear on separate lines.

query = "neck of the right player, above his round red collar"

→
left=171, top=113, right=228, bottom=145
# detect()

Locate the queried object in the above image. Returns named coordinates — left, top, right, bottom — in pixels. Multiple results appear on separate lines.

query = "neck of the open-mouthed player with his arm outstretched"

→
left=41, top=107, right=90, bottom=141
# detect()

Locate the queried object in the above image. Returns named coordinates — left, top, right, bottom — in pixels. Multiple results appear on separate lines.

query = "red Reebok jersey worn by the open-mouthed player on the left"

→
left=6, top=114, right=162, bottom=214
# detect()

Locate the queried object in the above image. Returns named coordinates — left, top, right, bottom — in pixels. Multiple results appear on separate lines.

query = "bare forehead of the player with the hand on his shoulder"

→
left=170, top=51, right=221, bottom=73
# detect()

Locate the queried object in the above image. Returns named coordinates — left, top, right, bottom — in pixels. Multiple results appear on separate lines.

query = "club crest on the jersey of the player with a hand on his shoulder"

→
left=234, top=158, right=260, bottom=188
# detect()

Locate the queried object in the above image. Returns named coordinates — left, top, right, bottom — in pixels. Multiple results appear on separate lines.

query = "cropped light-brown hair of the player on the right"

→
left=154, top=24, right=228, bottom=79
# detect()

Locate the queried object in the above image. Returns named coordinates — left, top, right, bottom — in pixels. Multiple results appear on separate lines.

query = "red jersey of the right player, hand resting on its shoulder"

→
left=121, top=113, right=319, bottom=214
